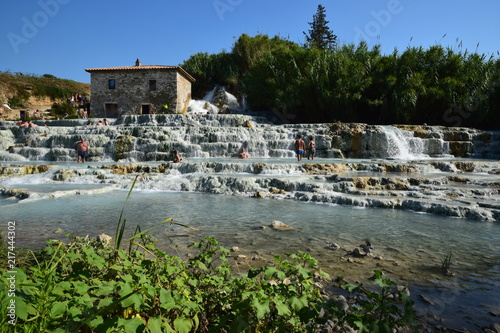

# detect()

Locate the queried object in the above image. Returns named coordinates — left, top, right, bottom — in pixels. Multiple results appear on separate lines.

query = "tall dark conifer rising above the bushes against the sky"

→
left=304, top=5, right=337, bottom=50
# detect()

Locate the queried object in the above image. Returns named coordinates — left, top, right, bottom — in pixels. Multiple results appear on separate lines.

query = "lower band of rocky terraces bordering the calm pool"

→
left=0, top=160, right=500, bottom=222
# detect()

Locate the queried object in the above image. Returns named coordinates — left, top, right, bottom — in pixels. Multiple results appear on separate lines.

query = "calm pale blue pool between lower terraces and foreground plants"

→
left=0, top=159, right=500, bottom=329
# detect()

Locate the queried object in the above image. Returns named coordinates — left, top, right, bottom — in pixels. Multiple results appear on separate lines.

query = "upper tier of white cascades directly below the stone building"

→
left=0, top=114, right=500, bottom=162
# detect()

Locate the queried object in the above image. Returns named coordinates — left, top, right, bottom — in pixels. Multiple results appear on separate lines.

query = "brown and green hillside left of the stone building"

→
left=0, top=73, right=90, bottom=108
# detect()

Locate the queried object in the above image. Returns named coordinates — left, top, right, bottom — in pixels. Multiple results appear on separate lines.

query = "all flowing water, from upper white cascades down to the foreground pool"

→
left=0, top=115, right=500, bottom=329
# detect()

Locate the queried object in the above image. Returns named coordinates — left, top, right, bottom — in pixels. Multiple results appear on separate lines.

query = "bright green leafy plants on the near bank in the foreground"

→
left=0, top=177, right=413, bottom=333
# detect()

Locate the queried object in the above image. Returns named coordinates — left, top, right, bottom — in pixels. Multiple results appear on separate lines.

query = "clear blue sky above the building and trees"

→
left=0, top=0, right=500, bottom=82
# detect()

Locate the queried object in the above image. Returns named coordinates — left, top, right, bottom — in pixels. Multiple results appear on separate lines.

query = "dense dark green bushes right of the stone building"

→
left=183, top=35, right=500, bottom=129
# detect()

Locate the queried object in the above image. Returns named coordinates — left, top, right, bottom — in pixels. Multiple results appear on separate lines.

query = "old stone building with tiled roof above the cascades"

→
left=85, top=59, right=195, bottom=118
